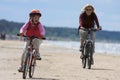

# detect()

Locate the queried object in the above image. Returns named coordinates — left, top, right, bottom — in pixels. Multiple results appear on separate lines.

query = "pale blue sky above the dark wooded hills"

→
left=0, top=0, right=120, bottom=31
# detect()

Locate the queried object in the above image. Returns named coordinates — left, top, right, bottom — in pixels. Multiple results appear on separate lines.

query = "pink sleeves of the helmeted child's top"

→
left=20, top=22, right=46, bottom=36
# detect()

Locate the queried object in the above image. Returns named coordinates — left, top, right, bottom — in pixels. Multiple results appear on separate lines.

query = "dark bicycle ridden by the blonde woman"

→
left=82, top=29, right=98, bottom=69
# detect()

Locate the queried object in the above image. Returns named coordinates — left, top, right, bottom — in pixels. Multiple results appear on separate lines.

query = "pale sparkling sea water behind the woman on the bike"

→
left=46, top=41, right=120, bottom=55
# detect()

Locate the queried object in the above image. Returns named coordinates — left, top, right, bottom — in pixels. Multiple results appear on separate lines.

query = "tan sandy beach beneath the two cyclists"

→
left=0, top=40, right=120, bottom=80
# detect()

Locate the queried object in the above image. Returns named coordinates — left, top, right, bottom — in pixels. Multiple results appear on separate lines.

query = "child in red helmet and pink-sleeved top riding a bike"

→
left=18, top=9, right=45, bottom=72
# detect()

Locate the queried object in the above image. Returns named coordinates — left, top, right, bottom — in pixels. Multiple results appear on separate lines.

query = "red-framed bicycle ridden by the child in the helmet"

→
left=17, top=34, right=46, bottom=79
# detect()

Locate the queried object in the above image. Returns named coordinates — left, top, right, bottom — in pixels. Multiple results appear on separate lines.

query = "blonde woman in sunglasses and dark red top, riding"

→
left=79, top=4, right=101, bottom=56
